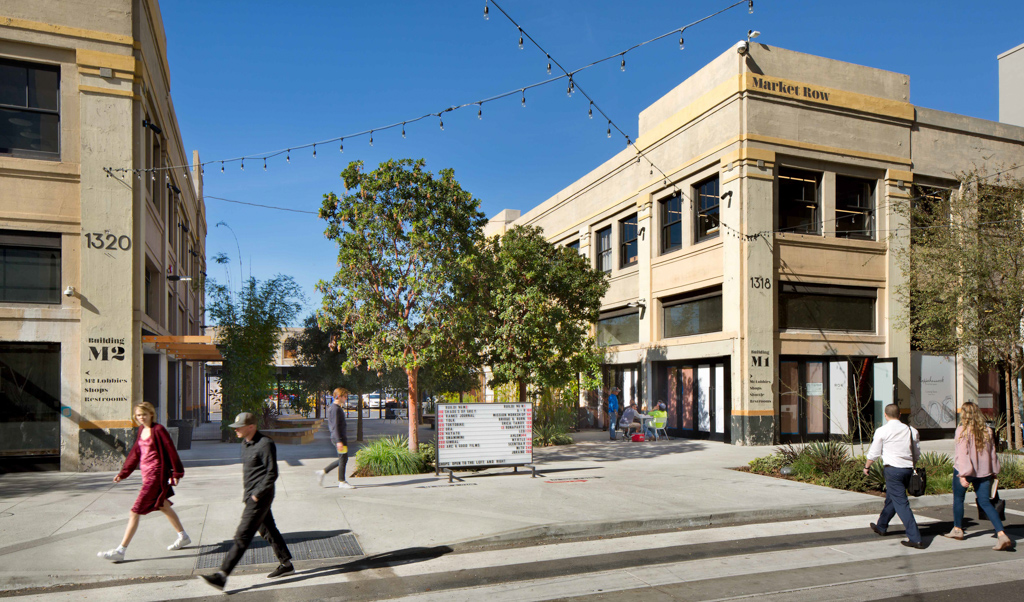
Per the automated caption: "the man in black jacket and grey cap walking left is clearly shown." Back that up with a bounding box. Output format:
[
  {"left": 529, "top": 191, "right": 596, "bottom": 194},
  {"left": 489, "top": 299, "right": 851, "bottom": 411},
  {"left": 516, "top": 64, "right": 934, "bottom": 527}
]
[{"left": 200, "top": 412, "right": 295, "bottom": 590}]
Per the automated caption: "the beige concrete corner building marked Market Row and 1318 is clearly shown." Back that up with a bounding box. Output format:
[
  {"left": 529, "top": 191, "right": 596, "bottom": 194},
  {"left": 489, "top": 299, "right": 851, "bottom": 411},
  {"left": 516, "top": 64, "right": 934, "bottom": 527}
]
[{"left": 488, "top": 43, "right": 1024, "bottom": 444}]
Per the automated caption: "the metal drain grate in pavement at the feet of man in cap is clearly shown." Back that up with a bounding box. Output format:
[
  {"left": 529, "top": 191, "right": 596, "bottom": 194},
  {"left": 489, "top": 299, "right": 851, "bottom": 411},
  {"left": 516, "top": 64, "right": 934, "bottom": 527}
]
[{"left": 196, "top": 531, "right": 362, "bottom": 569}]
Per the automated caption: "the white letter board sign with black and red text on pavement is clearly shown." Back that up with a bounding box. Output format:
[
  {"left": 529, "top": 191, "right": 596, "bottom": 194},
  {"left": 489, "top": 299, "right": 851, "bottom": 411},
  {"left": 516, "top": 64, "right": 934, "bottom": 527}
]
[{"left": 436, "top": 403, "right": 534, "bottom": 470}]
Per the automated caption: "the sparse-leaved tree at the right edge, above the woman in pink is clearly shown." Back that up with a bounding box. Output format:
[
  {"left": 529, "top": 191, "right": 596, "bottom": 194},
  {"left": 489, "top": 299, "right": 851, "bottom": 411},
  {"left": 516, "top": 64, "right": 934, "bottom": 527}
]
[{"left": 896, "top": 169, "right": 1024, "bottom": 448}]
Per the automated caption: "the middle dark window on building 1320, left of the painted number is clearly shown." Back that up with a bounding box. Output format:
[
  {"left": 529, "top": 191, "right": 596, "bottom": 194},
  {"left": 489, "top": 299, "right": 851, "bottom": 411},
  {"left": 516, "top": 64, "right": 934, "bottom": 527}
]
[{"left": 0, "top": 230, "right": 60, "bottom": 304}]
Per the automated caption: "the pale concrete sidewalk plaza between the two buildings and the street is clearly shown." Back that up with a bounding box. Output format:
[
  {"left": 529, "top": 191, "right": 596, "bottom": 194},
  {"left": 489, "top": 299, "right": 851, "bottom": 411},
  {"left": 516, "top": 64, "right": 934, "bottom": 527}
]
[{"left": 0, "top": 420, "right": 1003, "bottom": 591}]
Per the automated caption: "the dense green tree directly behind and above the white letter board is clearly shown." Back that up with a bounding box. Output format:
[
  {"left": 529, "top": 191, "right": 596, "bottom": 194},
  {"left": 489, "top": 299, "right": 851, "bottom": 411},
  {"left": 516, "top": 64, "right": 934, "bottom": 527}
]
[{"left": 480, "top": 226, "right": 608, "bottom": 401}]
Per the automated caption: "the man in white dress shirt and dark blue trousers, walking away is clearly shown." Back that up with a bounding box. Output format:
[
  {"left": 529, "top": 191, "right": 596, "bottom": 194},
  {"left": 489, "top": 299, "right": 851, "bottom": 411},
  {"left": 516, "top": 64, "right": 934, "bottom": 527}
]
[{"left": 864, "top": 403, "right": 925, "bottom": 549}]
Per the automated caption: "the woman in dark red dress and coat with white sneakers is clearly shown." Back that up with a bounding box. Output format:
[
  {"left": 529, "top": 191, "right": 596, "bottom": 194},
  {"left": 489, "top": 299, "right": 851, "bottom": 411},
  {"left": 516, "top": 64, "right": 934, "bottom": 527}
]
[{"left": 97, "top": 401, "right": 191, "bottom": 562}]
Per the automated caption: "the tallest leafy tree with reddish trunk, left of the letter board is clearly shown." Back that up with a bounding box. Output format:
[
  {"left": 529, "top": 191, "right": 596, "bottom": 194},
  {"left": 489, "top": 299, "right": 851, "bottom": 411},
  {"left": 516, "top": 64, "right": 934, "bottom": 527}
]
[{"left": 317, "top": 159, "right": 486, "bottom": 452}]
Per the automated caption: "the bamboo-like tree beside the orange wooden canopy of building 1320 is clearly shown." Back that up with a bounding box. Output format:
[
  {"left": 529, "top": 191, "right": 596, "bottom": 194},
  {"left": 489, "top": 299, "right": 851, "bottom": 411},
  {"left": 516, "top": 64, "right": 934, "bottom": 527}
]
[{"left": 207, "top": 274, "right": 304, "bottom": 430}]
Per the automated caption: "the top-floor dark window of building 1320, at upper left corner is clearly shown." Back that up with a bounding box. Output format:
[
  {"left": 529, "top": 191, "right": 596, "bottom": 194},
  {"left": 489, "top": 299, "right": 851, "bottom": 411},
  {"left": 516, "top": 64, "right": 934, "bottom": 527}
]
[{"left": 0, "top": 59, "right": 60, "bottom": 158}]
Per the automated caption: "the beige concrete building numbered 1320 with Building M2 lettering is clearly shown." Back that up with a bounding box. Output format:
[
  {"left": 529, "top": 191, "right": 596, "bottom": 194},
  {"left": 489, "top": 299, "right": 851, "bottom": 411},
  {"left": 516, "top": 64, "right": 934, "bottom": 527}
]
[{"left": 0, "top": 0, "right": 207, "bottom": 471}]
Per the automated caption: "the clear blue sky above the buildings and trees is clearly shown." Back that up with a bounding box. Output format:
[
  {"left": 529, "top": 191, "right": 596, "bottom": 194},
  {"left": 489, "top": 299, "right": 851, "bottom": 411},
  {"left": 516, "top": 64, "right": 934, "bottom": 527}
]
[{"left": 161, "top": 0, "right": 1024, "bottom": 313}]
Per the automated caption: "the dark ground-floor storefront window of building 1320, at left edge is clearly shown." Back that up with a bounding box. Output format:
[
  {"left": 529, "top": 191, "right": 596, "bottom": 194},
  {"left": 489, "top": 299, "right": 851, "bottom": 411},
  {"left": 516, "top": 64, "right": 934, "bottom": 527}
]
[{"left": 0, "top": 343, "right": 60, "bottom": 459}]
